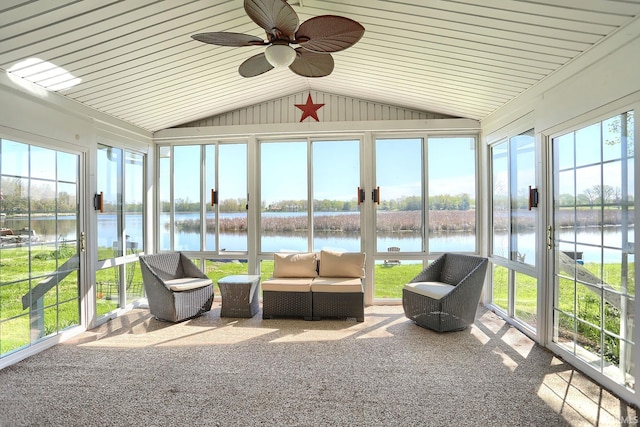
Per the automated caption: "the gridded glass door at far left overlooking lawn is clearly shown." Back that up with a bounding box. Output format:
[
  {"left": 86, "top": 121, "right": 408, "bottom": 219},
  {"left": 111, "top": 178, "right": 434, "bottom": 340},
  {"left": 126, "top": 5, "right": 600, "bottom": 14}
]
[{"left": 0, "top": 139, "right": 84, "bottom": 358}]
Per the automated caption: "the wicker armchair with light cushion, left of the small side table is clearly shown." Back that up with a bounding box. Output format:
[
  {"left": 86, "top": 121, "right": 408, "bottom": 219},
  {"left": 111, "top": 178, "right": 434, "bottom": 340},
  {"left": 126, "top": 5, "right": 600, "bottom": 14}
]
[{"left": 140, "top": 252, "right": 213, "bottom": 322}]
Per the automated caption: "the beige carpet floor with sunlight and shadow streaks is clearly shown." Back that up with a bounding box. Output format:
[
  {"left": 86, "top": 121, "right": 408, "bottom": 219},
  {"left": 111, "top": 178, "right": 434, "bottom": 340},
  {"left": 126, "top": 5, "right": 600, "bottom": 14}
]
[{"left": 0, "top": 301, "right": 636, "bottom": 427}]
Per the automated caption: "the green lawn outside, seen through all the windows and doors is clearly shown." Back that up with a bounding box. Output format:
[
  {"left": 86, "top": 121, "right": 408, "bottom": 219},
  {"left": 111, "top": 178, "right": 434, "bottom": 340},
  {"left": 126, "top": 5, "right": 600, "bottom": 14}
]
[{"left": 0, "top": 246, "right": 635, "bottom": 362}]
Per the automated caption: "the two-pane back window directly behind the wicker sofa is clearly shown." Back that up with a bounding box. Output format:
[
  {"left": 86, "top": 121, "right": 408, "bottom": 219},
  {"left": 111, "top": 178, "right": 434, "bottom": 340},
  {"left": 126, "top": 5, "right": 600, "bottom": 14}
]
[{"left": 260, "top": 140, "right": 361, "bottom": 252}]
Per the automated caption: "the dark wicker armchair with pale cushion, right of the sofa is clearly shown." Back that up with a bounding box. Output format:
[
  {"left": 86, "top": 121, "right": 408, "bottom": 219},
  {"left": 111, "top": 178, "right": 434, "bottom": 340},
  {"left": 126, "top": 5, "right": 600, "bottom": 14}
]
[{"left": 402, "top": 253, "right": 488, "bottom": 332}]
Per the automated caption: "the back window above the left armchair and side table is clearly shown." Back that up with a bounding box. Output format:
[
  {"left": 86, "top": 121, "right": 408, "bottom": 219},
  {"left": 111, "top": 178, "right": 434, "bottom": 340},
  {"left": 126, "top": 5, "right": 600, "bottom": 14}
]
[{"left": 158, "top": 143, "right": 248, "bottom": 254}]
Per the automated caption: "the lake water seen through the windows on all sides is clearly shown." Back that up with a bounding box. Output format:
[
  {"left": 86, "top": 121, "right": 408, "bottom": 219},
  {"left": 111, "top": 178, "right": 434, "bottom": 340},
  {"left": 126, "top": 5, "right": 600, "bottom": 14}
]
[{"left": 0, "top": 212, "right": 634, "bottom": 262}]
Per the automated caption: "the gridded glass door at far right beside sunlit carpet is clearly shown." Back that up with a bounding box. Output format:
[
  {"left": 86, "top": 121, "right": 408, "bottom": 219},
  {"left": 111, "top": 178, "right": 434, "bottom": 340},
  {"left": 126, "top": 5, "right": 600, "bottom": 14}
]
[{"left": 548, "top": 111, "right": 637, "bottom": 389}]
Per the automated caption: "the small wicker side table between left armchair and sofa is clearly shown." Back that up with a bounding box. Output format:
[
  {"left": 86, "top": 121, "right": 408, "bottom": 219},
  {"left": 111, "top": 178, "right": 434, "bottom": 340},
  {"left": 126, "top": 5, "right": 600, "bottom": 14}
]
[{"left": 218, "top": 274, "right": 260, "bottom": 317}]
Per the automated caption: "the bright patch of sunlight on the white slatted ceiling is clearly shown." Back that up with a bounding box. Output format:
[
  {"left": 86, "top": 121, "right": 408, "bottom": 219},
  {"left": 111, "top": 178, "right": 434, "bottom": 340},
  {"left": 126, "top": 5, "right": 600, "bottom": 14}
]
[{"left": 7, "top": 58, "right": 82, "bottom": 91}]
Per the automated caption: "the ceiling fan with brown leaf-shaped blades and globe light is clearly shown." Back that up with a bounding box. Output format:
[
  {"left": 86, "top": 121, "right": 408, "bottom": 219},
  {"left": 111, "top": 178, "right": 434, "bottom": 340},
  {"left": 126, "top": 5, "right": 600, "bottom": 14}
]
[{"left": 191, "top": 0, "right": 364, "bottom": 77}]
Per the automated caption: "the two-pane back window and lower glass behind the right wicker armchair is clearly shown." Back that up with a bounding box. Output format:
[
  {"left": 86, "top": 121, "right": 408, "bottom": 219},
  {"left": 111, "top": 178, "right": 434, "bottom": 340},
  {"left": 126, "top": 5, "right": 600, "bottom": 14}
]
[{"left": 374, "top": 136, "right": 477, "bottom": 299}]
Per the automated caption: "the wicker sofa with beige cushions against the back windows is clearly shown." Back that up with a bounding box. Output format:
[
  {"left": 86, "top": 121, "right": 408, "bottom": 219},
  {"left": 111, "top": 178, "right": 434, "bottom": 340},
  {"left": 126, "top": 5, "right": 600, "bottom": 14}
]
[{"left": 262, "top": 250, "right": 365, "bottom": 322}]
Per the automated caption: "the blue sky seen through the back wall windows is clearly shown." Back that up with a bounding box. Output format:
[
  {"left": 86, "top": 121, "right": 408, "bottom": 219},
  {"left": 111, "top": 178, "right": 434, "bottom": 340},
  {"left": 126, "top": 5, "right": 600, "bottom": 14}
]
[{"left": 152, "top": 137, "right": 475, "bottom": 205}]
